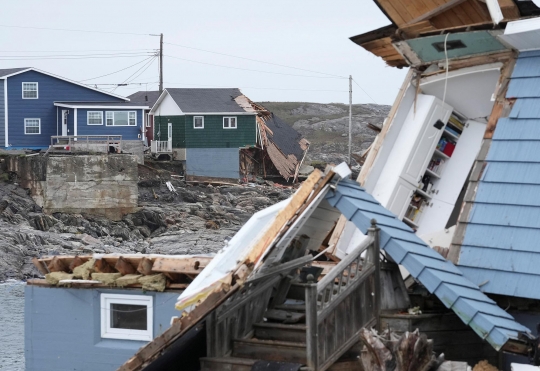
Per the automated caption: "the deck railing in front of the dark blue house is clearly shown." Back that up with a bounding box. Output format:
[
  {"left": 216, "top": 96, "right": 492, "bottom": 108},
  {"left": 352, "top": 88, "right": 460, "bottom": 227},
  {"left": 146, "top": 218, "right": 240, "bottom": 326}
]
[{"left": 49, "top": 135, "right": 122, "bottom": 153}]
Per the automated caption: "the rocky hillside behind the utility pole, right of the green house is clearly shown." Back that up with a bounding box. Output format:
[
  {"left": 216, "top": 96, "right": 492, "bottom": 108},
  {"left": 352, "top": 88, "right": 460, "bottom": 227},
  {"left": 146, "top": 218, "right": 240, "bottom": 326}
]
[{"left": 259, "top": 102, "right": 390, "bottom": 164}]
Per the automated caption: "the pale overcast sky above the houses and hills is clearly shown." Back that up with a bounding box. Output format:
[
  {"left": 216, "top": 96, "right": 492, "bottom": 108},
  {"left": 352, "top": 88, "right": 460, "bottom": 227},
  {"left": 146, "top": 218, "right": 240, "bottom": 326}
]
[{"left": 0, "top": 0, "right": 405, "bottom": 104}]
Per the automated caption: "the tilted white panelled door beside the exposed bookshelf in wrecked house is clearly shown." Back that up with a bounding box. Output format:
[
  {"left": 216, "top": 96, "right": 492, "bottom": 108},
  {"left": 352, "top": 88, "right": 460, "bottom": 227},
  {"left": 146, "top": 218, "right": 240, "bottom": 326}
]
[{"left": 401, "top": 99, "right": 452, "bottom": 185}]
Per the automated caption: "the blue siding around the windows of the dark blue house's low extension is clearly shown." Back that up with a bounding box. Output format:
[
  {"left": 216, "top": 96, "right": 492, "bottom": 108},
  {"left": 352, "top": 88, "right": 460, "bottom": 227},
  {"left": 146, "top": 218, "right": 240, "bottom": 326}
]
[{"left": 77, "top": 108, "right": 143, "bottom": 140}]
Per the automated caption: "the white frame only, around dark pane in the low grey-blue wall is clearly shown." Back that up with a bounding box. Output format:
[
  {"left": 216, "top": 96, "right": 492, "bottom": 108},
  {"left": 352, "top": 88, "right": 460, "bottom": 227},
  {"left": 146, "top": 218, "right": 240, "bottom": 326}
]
[{"left": 100, "top": 294, "right": 154, "bottom": 341}]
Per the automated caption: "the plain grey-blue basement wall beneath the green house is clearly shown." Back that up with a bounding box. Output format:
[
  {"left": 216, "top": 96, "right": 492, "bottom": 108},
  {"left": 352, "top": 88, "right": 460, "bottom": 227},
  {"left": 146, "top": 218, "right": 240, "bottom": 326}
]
[{"left": 186, "top": 148, "right": 240, "bottom": 179}]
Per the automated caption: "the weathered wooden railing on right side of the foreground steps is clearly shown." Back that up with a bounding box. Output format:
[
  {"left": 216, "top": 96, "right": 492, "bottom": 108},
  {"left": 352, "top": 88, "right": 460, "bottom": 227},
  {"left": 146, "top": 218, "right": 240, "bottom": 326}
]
[{"left": 306, "top": 222, "right": 380, "bottom": 371}]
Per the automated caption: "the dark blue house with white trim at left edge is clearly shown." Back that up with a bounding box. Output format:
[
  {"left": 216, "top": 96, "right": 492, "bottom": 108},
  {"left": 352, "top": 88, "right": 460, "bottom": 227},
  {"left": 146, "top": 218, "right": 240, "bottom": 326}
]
[{"left": 0, "top": 67, "right": 148, "bottom": 149}]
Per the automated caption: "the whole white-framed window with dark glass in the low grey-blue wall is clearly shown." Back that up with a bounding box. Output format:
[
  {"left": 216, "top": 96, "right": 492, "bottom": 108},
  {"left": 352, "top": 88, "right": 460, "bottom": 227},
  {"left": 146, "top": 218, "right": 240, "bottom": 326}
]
[{"left": 100, "top": 294, "right": 154, "bottom": 341}]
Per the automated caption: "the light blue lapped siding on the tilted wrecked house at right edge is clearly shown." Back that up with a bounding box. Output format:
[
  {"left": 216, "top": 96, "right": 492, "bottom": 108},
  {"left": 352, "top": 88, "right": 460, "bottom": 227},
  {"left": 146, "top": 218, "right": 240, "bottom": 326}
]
[{"left": 458, "top": 51, "right": 540, "bottom": 299}]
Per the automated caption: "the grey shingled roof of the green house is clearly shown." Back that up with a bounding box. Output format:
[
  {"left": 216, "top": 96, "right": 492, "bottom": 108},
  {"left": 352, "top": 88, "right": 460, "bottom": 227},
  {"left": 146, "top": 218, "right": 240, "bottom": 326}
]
[{"left": 165, "top": 88, "right": 246, "bottom": 113}]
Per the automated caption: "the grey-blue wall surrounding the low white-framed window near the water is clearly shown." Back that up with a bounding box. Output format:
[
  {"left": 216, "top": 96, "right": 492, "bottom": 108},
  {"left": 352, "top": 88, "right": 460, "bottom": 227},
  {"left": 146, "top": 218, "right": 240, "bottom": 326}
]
[{"left": 25, "top": 285, "right": 180, "bottom": 371}]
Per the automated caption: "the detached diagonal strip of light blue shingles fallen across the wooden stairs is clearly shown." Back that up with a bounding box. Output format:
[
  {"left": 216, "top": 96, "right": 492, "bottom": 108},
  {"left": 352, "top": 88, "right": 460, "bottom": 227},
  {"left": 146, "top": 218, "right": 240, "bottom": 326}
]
[{"left": 327, "top": 180, "right": 529, "bottom": 350}]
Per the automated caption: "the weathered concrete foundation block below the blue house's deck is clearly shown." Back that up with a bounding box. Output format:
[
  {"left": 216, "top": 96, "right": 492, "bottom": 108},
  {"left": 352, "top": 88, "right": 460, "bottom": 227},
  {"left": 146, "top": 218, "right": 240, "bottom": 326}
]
[{"left": 6, "top": 154, "right": 138, "bottom": 220}]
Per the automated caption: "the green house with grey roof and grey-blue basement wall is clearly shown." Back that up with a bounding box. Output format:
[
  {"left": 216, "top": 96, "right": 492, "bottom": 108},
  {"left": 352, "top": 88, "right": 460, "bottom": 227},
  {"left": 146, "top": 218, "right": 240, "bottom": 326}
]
[{"left": 149, "top": 88, "right": 259, "bottom": 179}]
